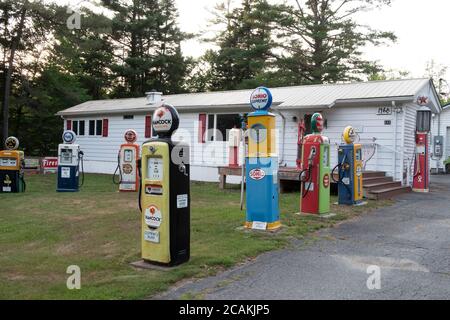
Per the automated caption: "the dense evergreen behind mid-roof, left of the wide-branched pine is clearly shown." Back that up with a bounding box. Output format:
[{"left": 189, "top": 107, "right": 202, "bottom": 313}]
[{"left": 197, "top": 0, "right": 276, "bottom": 90}]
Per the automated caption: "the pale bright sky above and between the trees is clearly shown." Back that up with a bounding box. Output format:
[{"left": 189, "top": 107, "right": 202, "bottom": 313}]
[{"left": 65, "top": 0, "right": 450, "bottom": 83}]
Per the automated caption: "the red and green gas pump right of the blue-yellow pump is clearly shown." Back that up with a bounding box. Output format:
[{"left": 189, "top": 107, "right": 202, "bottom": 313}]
[{"left": 300, "top": 113, "right": 331, "bottom": 214}]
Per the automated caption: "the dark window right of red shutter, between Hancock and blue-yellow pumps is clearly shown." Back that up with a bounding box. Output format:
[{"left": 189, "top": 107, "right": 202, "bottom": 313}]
[{"left": 208, "top": 113, "right": 243, "bottom": 141}]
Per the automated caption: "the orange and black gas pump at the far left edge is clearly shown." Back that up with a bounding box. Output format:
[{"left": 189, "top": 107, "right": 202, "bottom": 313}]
[{"left": 0, "top": 137, "right": 26, "bottom": 193}]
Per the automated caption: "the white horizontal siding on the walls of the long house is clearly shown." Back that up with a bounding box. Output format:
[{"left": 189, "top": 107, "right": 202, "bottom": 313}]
[{"left": 65, "top": 106, "right": 414, "bottom": 183}]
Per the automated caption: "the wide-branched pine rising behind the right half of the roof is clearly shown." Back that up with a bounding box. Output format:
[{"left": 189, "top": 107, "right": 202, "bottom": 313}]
[{"left": 277, "top": 0, "right": 396, "bottom": 85}]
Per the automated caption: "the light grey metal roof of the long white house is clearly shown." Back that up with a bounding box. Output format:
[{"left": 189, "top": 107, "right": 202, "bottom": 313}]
[{"left": 58, "top": 79, "right": 440, "bottom": 116}]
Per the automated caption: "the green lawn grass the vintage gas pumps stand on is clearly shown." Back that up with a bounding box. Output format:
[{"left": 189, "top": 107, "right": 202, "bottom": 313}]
[{"left": 0, "top": 174, "right": 390, "bottom": 299}]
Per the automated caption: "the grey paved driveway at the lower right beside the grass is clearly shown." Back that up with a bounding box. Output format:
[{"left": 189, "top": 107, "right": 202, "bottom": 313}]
[{"left": 159, "top": 176, "right": 450, "bottom": 300}]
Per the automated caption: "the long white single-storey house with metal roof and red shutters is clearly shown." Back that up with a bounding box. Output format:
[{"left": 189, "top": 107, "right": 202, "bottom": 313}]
[{"left": 58, "top": 79, "right": 440, "bottom": 184}]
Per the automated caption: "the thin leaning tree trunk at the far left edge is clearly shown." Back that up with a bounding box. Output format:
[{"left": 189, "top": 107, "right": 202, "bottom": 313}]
[{"left": 3, "top": 4, "right": 27, "bottom": 141}]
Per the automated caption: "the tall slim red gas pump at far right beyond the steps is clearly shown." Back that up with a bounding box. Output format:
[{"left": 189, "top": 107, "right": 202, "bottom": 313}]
[{"left": 413, "top": 104, "right": 431, "bottom": 192}]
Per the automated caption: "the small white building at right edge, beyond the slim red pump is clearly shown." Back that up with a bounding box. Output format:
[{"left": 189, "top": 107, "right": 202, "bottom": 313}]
[{"left": 431, "top": 104, "right": 450, "bottom": 172}]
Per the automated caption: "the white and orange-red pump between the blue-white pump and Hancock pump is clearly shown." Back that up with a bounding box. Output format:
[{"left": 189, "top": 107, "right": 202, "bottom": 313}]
[{"left": 113, "top": 129, "right": 140, "bottom": 192}]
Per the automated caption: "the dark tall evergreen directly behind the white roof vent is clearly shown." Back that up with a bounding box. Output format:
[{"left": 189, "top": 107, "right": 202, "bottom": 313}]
[{"left": 103, "top": 0, "right": 188, "bottom": 97}]
